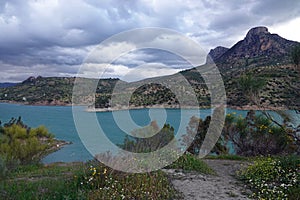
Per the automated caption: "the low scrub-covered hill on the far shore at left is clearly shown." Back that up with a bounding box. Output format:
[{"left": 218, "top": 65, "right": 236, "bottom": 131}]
[{"left": 0, "top": 76, "right": 119, "bottom": 105}]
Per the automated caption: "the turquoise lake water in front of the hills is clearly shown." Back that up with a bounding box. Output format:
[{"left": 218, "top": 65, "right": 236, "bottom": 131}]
[{"left": 0, "top": 103, "right": 298, "bottom": 163}]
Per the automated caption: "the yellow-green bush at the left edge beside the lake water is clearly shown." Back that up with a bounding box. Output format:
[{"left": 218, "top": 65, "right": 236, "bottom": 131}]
[{"left": 0, "top": 117, "right": 54, "bottom": 164}]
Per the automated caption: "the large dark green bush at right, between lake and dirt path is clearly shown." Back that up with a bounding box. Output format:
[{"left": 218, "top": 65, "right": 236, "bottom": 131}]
[{"left": 223, "top": 111, "right": 296, "bottom": 156}]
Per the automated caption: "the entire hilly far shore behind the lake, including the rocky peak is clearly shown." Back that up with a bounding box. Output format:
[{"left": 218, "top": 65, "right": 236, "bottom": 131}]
[{"left": 0, "top": 27, "right": 300, "bottom": 109}]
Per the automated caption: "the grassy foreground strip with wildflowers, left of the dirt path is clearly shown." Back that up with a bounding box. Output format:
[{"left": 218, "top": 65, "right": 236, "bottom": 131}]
[{"left": 0, "top": 161, "right": 177, "bottom": 200}]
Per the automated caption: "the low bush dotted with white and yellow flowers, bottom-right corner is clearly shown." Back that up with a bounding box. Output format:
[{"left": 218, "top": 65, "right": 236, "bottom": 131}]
[{"left": 239, "top": 156, "right": 300, "bottom": 200}]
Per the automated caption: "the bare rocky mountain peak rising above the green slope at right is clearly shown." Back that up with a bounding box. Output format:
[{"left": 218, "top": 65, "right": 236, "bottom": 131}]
[{"left": 208, "top": 27, "right": 299, "bottom": 71}]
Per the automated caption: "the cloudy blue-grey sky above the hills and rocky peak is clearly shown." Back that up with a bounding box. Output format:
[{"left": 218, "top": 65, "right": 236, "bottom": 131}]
[{"left": 0, "top": 0, "right": 300, "bottom": 82}]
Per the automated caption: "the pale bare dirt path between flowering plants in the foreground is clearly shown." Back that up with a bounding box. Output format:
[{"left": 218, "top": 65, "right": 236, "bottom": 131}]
[{"left": 166, "top": 160, "right": 249, "bottom": 200}]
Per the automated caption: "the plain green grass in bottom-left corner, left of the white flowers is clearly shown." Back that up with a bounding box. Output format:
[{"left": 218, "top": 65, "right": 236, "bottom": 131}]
[{"left": 0, "top": 163, "right": 83, "bottom": 200}]
